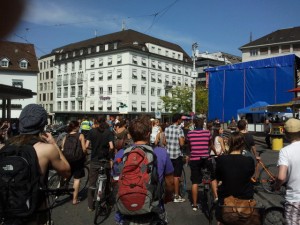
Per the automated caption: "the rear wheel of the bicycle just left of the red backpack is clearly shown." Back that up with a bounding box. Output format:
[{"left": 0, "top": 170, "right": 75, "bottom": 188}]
[{"left": 94, "top": 181, "right": 109, "bottom": 224}]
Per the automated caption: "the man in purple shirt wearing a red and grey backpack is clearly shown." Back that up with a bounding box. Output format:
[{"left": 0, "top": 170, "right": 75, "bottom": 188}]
[{"left": 113, "top": 116, "right": 174, "bottom": 224}]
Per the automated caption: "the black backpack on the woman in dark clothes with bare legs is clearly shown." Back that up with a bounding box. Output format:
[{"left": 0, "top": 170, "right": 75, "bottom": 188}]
[{"left": 63, "top": 133, "right": 84, "bottom": 162}]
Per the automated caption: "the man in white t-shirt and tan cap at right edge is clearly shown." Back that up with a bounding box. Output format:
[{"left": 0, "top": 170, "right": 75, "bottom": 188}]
[{"left": 275, "top": 118, "right": 300, "bottom": 225}]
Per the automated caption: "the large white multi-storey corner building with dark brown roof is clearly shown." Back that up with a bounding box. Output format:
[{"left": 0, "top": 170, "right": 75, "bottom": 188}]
[{"left": 40, "top": 30, "right": 194, "bottom": 122}]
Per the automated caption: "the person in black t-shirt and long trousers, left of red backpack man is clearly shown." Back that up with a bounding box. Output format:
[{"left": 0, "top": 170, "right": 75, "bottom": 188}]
[{"left": 86, "top": 117, "right": 114, "bottom": 211}]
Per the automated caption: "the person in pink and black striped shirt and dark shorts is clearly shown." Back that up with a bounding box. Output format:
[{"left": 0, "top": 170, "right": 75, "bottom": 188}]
[{"left": 187, "top": 118, "right": 217, "bottom": 211}]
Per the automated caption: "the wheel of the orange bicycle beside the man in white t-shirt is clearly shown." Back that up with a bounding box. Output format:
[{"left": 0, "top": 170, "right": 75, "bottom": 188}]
[{"left": 259, "top": 164, "right": 285, "bottom": 194}]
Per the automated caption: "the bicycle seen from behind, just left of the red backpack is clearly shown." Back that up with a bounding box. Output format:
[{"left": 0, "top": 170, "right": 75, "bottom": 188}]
[{"left": 94, "top": 159, "right": 112, "bottom": 224}]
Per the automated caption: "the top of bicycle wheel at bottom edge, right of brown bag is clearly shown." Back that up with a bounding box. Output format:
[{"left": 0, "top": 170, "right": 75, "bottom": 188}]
[{"left": 263, "top": 206, "right": 285, "bottom": 225}]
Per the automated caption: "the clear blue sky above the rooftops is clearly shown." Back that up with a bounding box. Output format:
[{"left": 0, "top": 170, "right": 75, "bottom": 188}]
[{"left": 6, "top": 0, "right": 300, "bottom": 56}]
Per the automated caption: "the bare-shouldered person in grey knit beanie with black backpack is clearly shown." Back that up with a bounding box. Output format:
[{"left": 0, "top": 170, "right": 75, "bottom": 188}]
[{"left": 0, "top": 104, "right": 70, "bottom": 225}]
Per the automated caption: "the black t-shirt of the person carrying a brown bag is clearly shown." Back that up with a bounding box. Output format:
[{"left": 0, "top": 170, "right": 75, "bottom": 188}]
[{"left": 216, "top": 155, "right": 255, "bottom": 199}]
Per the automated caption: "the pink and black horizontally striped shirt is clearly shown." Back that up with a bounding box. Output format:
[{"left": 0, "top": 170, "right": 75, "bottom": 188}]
[{"left": 187, "top": 129, "right": 211, "bottom": 160}]
